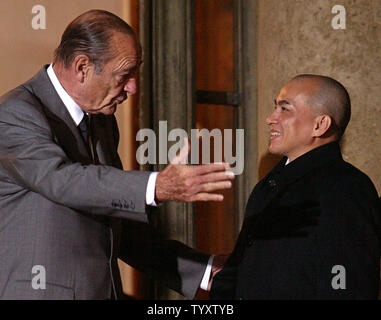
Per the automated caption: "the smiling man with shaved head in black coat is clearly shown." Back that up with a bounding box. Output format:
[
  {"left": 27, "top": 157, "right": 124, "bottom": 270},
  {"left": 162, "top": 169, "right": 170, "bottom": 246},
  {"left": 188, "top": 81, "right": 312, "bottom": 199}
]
[{"left": 210, "top": 75, "right": 381, "bottom": 300}]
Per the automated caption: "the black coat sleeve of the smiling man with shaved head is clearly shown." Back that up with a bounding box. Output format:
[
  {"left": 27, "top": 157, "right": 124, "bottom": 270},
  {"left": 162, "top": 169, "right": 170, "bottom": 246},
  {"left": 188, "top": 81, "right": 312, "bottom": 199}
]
[{"left": 315, "top": 174, "right": 381, "bottom": 299}]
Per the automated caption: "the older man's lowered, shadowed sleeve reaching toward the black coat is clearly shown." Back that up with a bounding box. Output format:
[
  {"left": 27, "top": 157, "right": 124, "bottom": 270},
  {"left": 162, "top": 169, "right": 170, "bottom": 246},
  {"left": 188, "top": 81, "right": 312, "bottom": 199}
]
[{"left": 118, "top": 220, "right": 209, "bottom": 299}]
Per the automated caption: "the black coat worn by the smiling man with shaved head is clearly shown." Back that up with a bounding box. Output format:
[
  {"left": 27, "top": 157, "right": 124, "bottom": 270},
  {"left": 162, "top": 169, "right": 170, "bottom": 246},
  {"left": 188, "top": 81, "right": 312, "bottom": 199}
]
[{"left": 211, "top": 142, "right": 381, "bottom": 299}]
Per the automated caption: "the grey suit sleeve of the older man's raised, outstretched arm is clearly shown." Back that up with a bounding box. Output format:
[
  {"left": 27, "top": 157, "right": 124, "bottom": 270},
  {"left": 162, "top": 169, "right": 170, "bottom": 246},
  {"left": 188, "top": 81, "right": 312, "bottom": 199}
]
[{"left": 0, "top": 99, "right": 149, "bottom": 216}]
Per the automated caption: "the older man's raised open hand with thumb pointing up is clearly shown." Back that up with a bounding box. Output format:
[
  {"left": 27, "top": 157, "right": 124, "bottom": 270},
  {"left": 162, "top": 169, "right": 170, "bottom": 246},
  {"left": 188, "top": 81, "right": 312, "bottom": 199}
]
[{"left": 155, "top": 139, "right": 234, "bottom": 202}]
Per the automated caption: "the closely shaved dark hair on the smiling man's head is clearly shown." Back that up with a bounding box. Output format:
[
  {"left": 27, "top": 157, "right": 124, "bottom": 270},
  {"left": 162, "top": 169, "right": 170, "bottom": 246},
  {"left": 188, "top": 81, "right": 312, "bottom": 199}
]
[{"left": 291, "top": 74, "right": 351, "bottom": 140}]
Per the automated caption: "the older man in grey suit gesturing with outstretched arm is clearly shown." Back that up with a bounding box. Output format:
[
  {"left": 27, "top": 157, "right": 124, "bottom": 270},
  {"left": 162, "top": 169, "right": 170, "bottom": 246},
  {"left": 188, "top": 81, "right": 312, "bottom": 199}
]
[{"left": 0, "top": 10, "right": 232, "bottom": 299}]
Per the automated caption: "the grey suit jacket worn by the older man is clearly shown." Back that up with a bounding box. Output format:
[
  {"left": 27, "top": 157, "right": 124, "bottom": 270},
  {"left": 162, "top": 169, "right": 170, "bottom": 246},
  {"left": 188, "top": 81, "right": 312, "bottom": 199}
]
[{"left": 0, "top": 66, "right": 208, "bottom": 299}]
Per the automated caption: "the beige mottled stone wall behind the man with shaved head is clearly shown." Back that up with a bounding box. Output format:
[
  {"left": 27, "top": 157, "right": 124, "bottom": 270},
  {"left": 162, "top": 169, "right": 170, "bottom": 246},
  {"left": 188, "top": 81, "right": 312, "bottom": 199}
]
[{"left": 258, "top": 0, "right": 381, "bottom": 194}]
